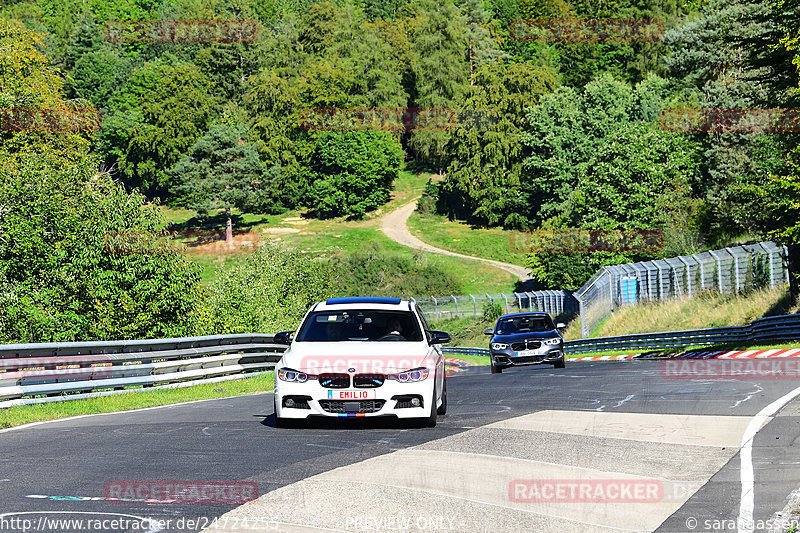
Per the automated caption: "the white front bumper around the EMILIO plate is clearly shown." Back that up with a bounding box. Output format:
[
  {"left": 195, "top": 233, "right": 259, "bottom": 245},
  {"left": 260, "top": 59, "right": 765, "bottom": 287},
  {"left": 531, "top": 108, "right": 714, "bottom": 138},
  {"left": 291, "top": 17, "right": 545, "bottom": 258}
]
[{"left": 275, "top": 375, "right": 435, "bottom": 419}]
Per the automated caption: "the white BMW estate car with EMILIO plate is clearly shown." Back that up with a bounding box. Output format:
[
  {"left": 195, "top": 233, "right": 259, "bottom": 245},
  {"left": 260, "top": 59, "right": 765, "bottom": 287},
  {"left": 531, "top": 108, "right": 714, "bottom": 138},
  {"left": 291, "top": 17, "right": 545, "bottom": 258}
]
[{"left": 274, "top": 297, "right": 450, "bottom": 427}]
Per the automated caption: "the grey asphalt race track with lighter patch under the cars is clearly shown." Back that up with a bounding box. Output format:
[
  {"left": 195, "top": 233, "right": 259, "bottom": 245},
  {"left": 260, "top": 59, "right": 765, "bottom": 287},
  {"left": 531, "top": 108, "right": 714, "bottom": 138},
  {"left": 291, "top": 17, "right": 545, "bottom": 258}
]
[{"left": 0, "top": 361, "right": 800, "bottom": 533}]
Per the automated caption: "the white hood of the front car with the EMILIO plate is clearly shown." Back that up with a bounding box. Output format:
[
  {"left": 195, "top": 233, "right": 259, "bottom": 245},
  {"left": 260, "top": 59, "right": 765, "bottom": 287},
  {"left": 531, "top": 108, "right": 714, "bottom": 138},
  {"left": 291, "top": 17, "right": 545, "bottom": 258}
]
[{"left": 282, "top": 341, "right": 435, "bottom": 374}]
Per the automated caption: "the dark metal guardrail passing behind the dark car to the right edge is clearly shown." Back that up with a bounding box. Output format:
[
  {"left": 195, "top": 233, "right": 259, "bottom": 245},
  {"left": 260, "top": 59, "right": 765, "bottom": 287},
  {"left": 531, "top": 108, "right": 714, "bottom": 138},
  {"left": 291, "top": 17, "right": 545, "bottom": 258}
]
[{"left": 443, "top": 314, "right": 800, "bottom": 356}]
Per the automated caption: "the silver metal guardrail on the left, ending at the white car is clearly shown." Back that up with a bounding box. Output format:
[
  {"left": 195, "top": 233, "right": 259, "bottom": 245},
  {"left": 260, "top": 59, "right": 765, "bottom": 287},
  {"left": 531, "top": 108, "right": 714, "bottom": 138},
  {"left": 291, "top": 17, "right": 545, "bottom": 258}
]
[{"left": 0, "top": 334, "right": 286, "bottom": 408}]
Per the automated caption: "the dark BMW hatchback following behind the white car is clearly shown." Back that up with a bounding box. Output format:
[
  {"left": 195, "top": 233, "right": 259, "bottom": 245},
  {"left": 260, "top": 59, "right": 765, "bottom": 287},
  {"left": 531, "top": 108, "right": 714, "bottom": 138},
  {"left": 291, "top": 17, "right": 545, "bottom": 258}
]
[{"left": 484, "top": 313, "right": 565, "bottom": 374}]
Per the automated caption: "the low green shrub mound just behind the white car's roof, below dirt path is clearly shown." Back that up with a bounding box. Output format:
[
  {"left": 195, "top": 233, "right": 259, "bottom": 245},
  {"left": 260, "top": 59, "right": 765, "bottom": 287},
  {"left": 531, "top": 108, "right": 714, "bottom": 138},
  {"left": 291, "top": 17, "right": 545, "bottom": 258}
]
[{"left": 334, "top": 243, "right": 463, "bottom": 296}]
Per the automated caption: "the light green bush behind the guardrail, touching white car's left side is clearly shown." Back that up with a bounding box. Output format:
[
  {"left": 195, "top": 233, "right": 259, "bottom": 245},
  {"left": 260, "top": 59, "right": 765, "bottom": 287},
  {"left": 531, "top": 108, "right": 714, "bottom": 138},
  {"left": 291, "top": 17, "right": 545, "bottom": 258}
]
[{"left": 196, "top": 245, "right": 335, "bottom": 334}]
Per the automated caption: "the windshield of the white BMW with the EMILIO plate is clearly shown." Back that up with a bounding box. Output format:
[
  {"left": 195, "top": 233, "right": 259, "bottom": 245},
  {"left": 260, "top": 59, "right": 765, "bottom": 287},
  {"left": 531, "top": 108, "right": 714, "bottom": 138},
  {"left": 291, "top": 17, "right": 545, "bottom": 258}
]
[{"left": 296, "top": 309, "right": 422, "bottom": 342}]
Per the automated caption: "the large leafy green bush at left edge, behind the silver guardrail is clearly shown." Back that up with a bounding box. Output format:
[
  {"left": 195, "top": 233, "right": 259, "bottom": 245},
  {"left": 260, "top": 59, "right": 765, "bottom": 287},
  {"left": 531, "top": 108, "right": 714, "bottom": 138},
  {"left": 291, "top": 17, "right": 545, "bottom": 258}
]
[{"left": 0, "top": 154, "right": 201, "bottom": 342}]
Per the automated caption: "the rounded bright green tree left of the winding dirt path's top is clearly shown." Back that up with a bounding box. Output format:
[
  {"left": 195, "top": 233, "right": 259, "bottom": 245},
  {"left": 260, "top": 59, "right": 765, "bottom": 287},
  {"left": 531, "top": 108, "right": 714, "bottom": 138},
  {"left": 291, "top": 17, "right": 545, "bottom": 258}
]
[{"left": 308, "top": 132, "right": 403, "bottom": 218}]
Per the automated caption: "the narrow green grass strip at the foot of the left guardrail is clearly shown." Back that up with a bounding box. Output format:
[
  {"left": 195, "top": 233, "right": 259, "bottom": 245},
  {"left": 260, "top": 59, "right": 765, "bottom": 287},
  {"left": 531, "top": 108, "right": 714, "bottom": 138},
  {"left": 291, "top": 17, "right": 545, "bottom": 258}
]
[{"left": 0, "top": 372, "right": 274, "bottom": 429}]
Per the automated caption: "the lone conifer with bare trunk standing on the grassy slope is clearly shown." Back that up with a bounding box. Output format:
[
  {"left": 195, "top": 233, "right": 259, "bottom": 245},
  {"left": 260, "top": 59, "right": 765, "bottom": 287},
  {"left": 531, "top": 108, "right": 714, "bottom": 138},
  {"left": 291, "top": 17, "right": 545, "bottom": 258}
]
[{"left": 170, "top": 124, "right": 277, "bottom": 245}]
